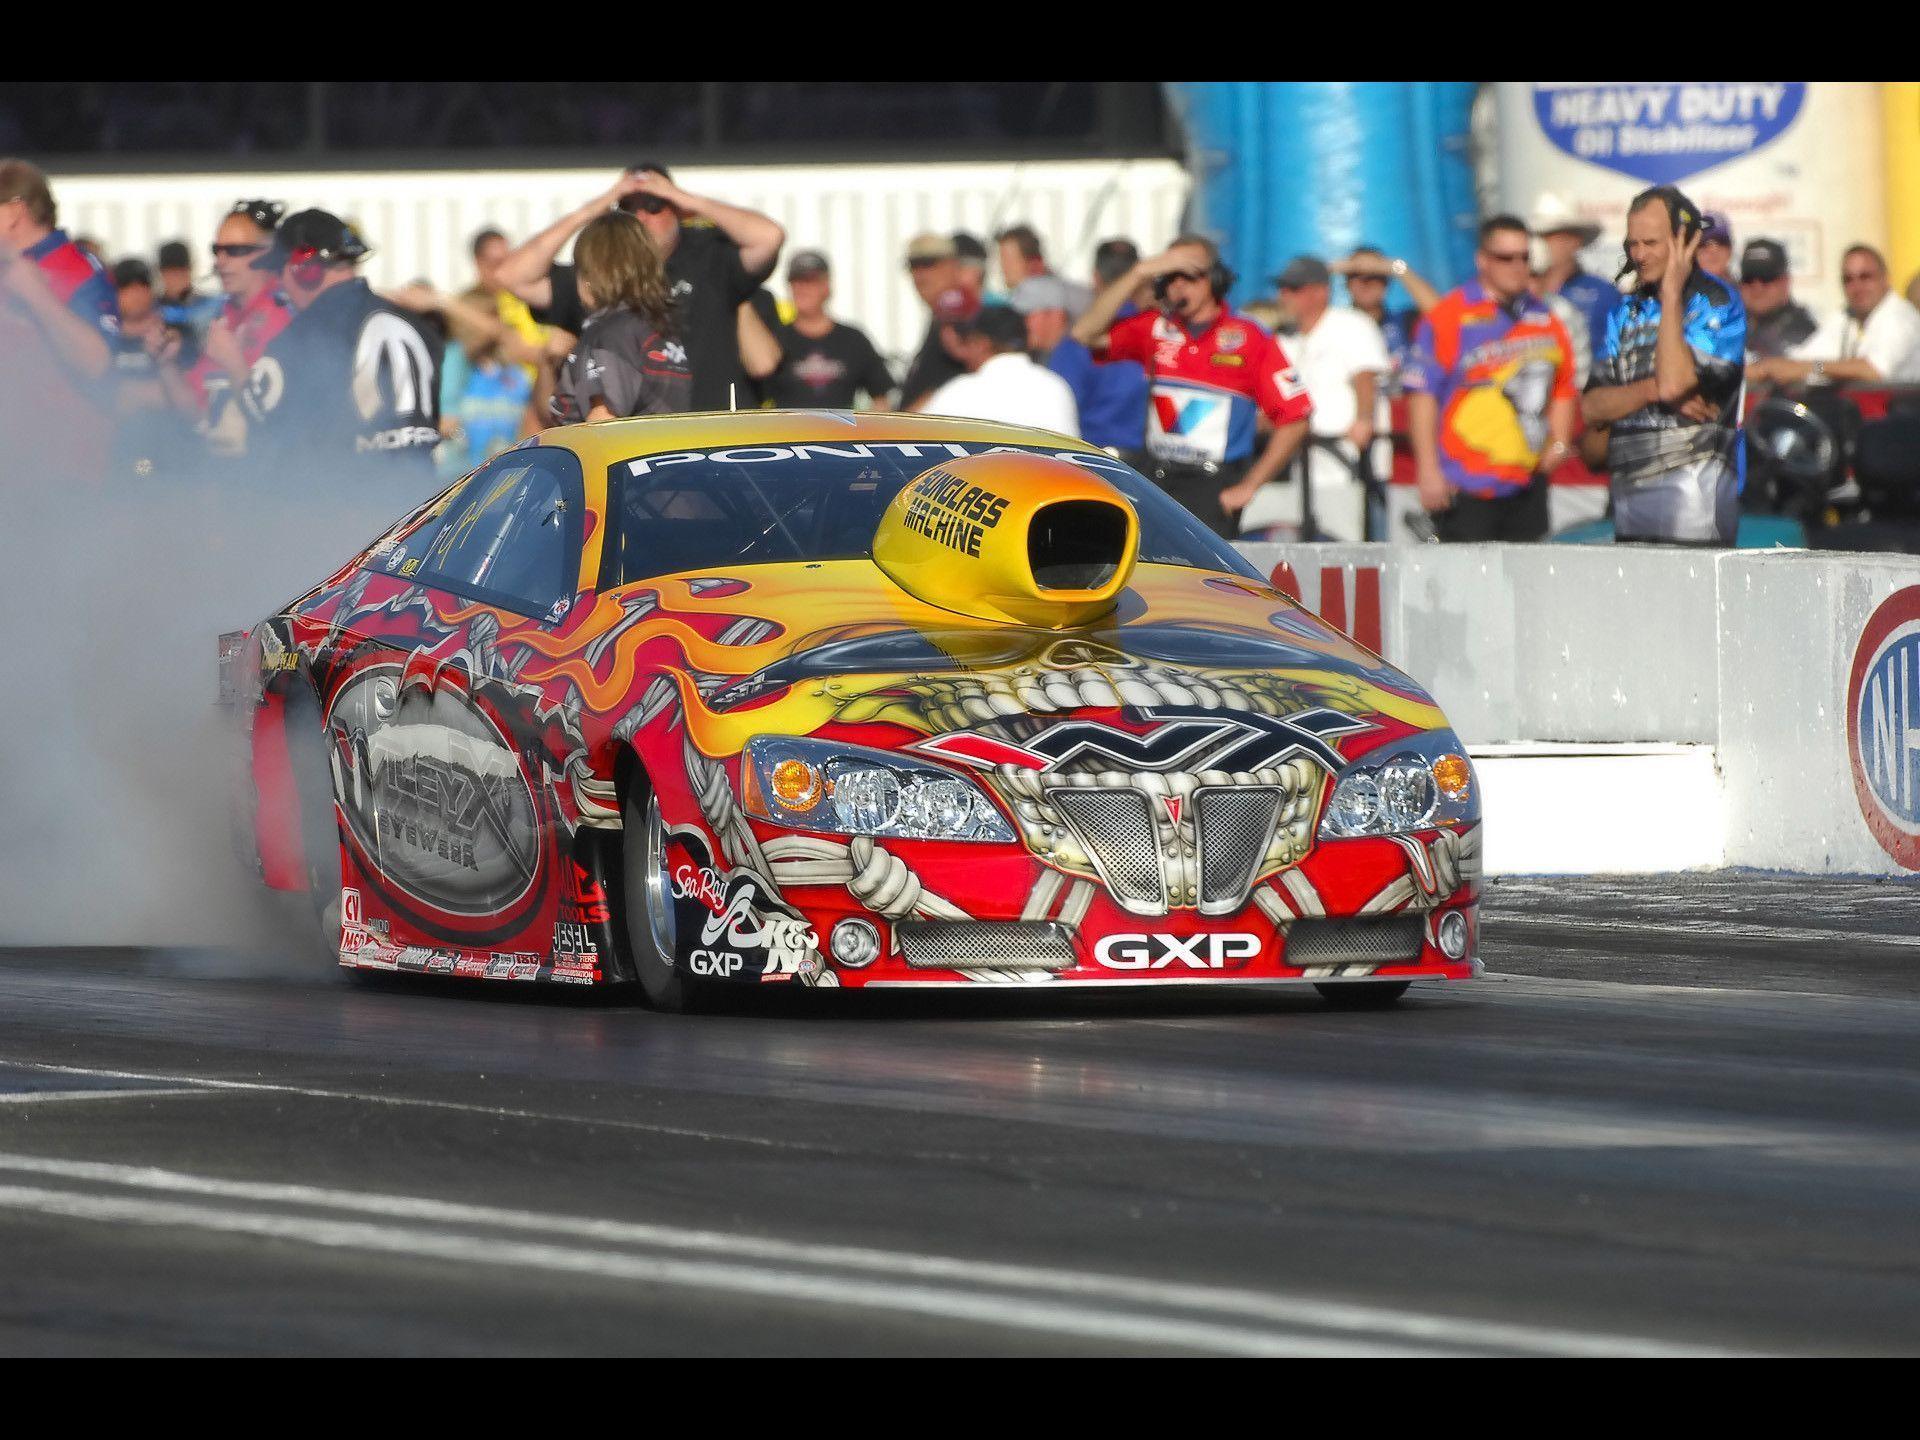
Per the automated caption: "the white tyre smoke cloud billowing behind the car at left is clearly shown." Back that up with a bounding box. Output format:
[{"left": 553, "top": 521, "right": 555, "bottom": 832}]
[{"left": 0, "top": 368, "right": 430, "bottom": 954}]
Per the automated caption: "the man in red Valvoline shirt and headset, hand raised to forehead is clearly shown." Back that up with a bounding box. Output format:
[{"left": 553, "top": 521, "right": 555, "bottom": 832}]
[{"left": 1073, "top": 234, "right": 1313, "bottom": 538}]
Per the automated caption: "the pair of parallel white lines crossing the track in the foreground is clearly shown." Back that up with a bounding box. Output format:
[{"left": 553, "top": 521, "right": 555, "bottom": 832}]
[{"left": 0, "top": 1152, "right": 1711, "bottom": 1356}]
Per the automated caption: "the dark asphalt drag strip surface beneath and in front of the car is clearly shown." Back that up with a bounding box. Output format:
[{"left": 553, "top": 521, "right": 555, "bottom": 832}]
[{"left": 0, "top": 876, "right": 1920, "bottom": 1356}]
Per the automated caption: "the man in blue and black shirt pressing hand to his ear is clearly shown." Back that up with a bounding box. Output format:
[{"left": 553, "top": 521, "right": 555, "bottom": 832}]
[{"left": 1580, "top": 186, "right": 1747, "bottom": 545}]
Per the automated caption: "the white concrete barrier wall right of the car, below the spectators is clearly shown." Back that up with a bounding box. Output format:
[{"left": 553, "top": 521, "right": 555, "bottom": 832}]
[{"left": 1240, "top": 543, "right": 1920, "bottom": 876}]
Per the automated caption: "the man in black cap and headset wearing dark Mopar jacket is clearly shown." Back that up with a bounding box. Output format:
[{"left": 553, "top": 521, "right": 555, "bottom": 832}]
[{"left": 240, "top": 209, "right": 440, "bottom": 493}]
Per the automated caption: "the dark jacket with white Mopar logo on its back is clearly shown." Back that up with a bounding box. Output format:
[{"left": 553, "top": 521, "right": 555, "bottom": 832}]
[{"left": 242, "top": 280, "right": 440, "bottom": 478}]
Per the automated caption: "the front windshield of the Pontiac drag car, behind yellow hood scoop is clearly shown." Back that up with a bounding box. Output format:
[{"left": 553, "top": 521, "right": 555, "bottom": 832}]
[{"left": 607, "top": 440, "right": 1261, "bottom": 584}]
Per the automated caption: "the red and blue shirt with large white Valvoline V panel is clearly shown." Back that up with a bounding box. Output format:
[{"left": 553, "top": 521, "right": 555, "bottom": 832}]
[{"left": 1102, "top": 311, "right": 1313, "bottom": 465}]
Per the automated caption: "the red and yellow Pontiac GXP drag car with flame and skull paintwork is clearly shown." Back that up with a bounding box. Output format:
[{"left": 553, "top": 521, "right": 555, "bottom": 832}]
[{"left": 223, "top": 411, "right": 1480, "bottom": 1010}]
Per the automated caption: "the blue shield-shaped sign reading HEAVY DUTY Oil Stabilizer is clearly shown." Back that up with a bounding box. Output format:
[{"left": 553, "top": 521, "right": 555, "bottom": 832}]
[{"left": 1534, "top": 81, "right": 1807, "bottom": 184}]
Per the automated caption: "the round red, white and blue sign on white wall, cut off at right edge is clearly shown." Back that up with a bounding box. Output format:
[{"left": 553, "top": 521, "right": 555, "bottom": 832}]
[{"left": 1847, "top": 586, "right": 1920, "bottom": 870}]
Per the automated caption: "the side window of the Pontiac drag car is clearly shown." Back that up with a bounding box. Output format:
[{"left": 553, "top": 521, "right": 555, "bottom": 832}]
[{"left": 409, "top": 447, "right": 586, "bottom": 616}]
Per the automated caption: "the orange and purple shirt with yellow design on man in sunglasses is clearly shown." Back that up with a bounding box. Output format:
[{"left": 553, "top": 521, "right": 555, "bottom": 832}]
[{"left": 1402, "top": 280, "right": 1576, "bottom": 497}]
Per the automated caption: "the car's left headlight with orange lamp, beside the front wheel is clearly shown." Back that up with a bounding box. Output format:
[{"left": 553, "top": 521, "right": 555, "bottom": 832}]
[{"left": 741, "top": 735, "right": 1014, "bottom": 845}]
